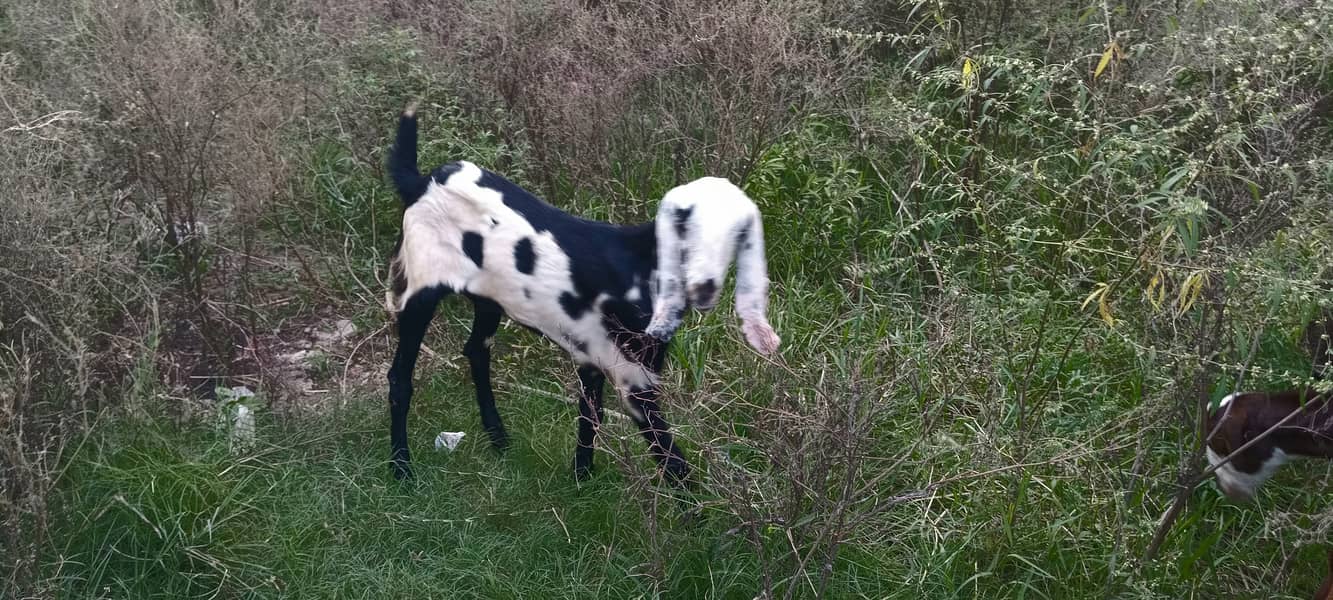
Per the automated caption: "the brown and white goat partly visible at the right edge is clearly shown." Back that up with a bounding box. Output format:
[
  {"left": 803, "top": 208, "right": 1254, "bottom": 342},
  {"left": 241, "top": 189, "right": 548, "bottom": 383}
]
[{"left": 1205, "top": 389, "right": 1333, "bottom": 501}]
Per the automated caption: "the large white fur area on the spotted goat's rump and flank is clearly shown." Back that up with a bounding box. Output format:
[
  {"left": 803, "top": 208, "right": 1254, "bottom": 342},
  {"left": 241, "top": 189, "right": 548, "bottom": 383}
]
[{"left": 395, "top": 161, "right": 657, "bottom": 408}]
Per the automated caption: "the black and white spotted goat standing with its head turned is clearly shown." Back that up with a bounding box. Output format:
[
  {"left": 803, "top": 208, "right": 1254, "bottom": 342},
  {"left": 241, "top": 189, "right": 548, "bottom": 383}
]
[{"left": 387, "top": 107, "right": 778, "bottom": 481}]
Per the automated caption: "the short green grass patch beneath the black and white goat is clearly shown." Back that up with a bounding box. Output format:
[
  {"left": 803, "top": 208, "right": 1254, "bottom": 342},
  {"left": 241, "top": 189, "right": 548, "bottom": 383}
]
[{"left": 56, "top": 365, "right": 881, "bottom": 597}]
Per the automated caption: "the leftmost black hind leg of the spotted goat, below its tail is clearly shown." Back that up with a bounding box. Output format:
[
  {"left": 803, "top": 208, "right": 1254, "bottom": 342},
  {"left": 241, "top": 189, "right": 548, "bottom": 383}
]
[{"left": 389, "top": 288, "right": 448, "bottom": 480}]
